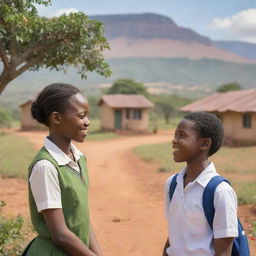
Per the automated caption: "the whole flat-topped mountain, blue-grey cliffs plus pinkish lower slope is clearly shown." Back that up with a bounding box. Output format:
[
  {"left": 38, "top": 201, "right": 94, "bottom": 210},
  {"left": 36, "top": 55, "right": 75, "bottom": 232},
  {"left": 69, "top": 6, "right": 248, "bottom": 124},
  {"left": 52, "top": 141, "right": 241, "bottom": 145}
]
[{"left": 90, "top": 13, "right": 256, "bottom": 63}]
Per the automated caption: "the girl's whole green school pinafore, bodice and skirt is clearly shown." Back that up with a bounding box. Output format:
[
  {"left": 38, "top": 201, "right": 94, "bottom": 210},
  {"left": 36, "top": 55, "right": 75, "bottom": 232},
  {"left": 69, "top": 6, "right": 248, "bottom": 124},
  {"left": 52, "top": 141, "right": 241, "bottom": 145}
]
[{"left": 23, "top": 147, "right": 89, "bottom": 256}]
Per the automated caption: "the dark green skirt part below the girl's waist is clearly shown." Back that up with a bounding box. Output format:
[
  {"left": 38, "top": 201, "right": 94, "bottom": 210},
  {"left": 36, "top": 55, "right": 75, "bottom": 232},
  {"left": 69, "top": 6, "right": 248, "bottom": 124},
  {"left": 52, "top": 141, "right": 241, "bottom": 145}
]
[{"left": 22, "top": 236, "right": 68, "bottom": 256}]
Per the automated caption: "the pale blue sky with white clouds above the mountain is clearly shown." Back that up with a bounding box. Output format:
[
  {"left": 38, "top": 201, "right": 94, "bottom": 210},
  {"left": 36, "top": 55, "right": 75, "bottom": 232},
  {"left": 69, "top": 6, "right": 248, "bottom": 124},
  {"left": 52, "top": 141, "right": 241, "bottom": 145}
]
[{"left": 38, "top": 0, "right": 256, "bottom": 43}]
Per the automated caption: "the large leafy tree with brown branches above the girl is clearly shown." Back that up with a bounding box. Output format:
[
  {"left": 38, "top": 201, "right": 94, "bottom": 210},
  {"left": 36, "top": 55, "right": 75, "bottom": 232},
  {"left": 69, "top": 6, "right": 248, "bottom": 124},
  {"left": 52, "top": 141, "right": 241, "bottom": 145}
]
[{"left": 0, "top": 0, "right": 111, "bottom": 94}]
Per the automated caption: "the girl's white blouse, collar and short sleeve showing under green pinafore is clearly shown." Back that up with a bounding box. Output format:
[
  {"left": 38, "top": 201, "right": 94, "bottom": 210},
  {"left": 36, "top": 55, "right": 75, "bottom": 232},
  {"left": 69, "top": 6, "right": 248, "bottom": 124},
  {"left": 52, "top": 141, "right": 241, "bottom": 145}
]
[{"left": 29, "top": 138, "right": 83, "bottom": 212}]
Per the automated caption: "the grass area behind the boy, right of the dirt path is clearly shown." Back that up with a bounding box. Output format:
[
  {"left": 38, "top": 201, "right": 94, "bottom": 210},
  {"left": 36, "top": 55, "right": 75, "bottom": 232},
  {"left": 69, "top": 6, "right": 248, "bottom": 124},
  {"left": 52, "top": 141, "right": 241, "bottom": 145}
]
[{"left": 134, "top": 143, "right": 256, "bottom": 204}]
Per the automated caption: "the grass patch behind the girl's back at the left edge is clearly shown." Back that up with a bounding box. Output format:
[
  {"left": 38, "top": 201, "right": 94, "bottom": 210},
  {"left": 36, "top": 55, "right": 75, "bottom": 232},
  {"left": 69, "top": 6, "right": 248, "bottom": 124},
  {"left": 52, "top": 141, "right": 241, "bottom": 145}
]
[{"left": 0, "top": 132, "right": 36, "bottom": 178}]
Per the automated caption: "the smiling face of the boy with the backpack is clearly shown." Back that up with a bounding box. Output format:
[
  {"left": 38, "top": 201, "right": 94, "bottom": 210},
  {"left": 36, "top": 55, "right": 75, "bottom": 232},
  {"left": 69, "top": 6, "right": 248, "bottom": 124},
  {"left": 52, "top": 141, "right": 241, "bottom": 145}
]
[{"left": 172, "top": 119, "right": 204, "bottom": 163}]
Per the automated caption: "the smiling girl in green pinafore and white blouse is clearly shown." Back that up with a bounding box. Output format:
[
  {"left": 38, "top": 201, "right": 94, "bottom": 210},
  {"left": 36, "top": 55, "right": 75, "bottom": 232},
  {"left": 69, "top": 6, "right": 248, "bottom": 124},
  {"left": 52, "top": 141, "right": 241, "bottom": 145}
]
[{"left": 23, "top": 83, "right": 103, "bottom": 256}]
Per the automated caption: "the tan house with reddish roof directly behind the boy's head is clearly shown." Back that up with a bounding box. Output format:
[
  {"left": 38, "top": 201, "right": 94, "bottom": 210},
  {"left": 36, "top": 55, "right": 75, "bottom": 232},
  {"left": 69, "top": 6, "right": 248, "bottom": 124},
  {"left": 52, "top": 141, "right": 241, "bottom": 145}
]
[{"left": 181, "top": 90, "right": 256, "bottom": 145}]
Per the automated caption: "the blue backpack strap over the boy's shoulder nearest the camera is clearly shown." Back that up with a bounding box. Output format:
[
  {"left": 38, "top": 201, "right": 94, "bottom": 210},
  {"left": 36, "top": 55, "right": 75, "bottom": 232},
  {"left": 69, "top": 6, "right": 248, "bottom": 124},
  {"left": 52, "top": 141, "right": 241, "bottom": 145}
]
[{"left": 203, "top": 175, "right": 230, "bottom": 229}]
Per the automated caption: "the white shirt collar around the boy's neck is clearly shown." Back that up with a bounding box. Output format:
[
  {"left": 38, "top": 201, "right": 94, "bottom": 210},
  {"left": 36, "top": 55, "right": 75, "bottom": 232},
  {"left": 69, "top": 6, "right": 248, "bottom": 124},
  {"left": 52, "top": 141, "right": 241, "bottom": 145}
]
[{"left": 177, "top": 162, "right": 217, "bottom": 187}]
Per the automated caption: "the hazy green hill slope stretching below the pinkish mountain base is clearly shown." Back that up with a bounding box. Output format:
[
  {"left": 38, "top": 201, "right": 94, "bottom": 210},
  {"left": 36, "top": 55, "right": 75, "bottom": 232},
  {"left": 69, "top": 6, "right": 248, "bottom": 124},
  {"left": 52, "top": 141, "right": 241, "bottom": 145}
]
[{"left": 1, "top": 58, "right": 256, "bottom": 105}]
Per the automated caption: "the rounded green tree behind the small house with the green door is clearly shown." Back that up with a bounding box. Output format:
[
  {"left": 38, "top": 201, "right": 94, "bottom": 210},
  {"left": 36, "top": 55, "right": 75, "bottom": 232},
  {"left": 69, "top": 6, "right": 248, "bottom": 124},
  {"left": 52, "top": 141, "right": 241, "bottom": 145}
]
[{"left": 107, "top": 79, "right": 148, "bottom": 96}]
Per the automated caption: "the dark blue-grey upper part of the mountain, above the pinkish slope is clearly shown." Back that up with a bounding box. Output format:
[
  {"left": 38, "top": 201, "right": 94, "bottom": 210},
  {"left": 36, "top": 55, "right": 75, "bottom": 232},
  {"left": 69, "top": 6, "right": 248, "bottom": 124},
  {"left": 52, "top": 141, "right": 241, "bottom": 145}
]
[{"left": 91, "top": 13, "right": 211, "bottom": 45}]
